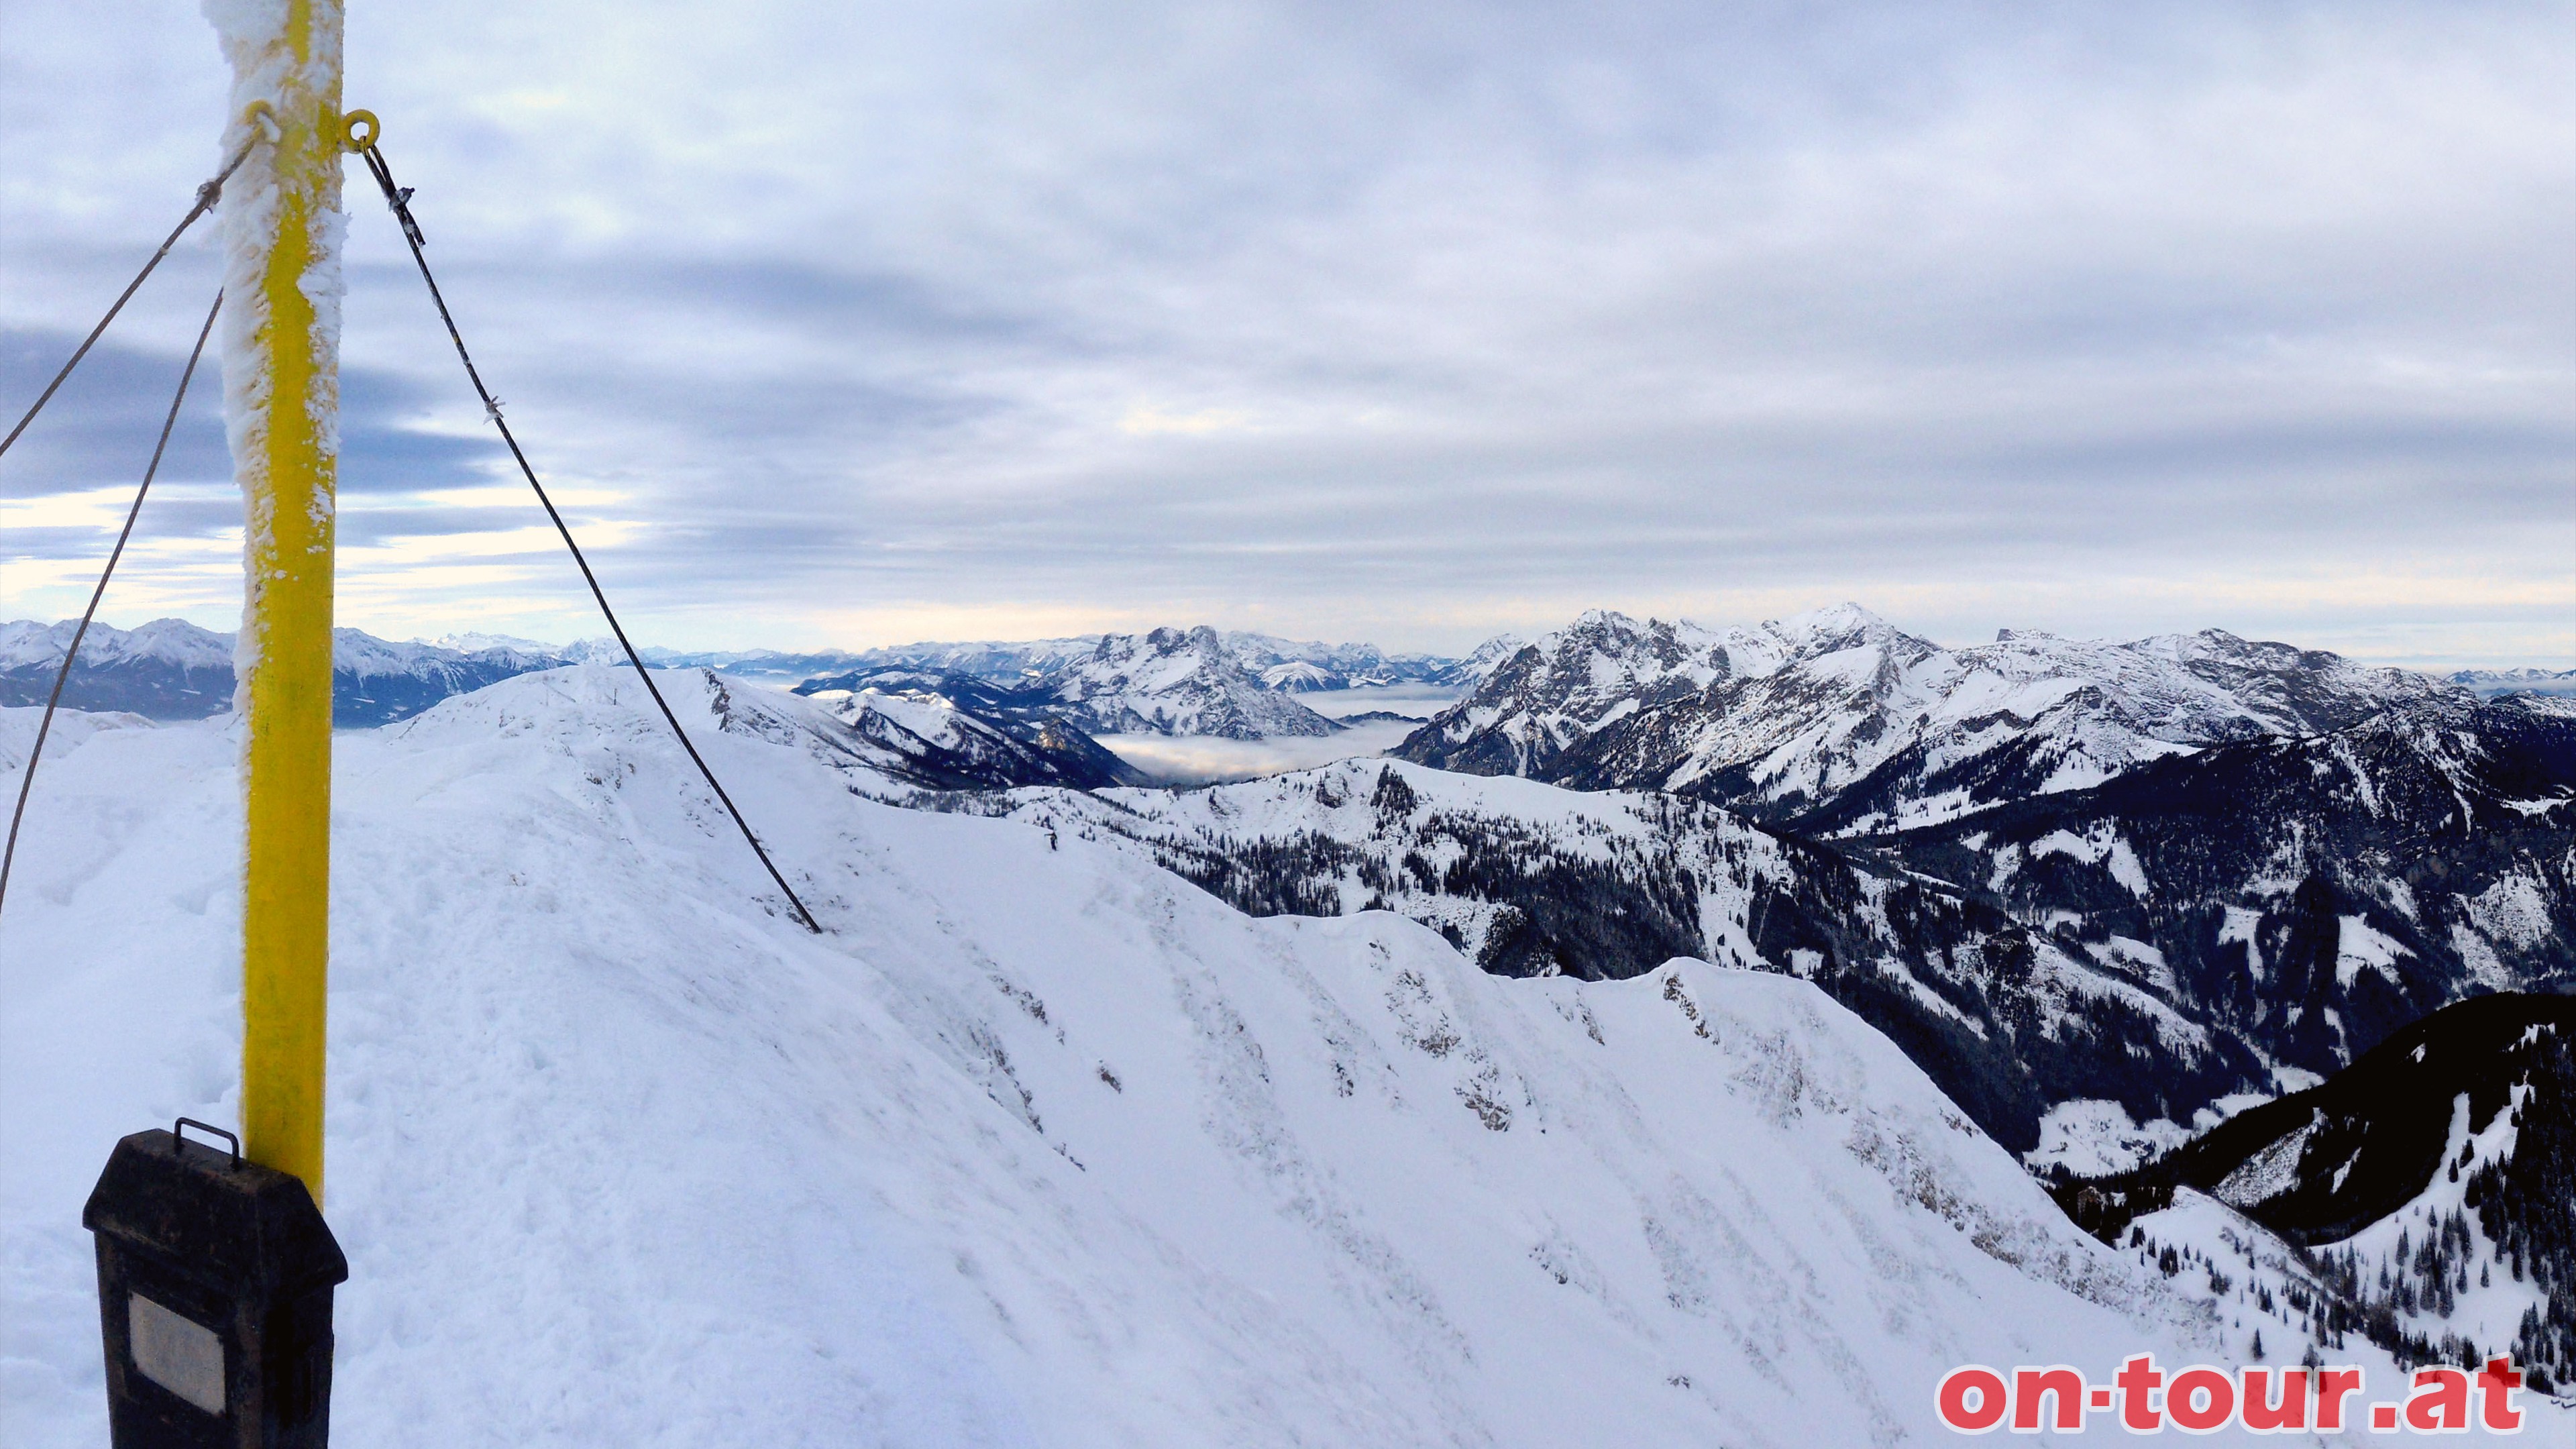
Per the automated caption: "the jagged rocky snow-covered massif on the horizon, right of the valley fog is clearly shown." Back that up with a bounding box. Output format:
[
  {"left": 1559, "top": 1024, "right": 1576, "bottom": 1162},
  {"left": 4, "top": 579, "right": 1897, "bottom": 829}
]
[{"left": 1404, "top": 603, "right": 2457, "bottom": 833}]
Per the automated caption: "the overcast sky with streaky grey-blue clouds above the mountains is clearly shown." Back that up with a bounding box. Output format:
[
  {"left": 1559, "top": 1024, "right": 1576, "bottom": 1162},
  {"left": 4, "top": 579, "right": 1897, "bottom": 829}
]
[{"left": 0, "top": 0, "right": 2576, "bottom": 667}]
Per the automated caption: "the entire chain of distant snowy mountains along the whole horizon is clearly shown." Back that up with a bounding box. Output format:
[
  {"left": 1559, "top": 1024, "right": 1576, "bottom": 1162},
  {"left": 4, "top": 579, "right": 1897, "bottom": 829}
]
[{"left": 20, "top": 606, "right": 2576, "bottom": 757}]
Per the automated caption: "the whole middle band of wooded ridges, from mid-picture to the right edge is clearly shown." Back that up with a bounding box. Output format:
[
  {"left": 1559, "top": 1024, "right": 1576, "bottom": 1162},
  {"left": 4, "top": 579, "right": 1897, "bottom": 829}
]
[{"left": 966, "top": 699, "right": 2576, "bottom": 1150}]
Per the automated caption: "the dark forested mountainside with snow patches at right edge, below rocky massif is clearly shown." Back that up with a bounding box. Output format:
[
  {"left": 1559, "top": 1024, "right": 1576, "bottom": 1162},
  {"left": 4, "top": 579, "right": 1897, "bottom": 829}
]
[{"left": 1849, "top": 699, "right": 2576, "bottom": 1073}]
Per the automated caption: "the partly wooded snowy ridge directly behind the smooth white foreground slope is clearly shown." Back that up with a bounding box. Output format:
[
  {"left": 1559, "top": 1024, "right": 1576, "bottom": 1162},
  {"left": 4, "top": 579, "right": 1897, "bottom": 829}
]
[{"left": 968, "top": 761, "right": 2272, "bottom": 1150}]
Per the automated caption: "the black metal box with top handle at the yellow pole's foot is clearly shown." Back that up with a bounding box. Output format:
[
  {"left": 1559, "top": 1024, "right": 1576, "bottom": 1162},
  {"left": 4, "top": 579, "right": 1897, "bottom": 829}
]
[{"left": 80, "top": 1122, "right": 347, "bottom": 1449}]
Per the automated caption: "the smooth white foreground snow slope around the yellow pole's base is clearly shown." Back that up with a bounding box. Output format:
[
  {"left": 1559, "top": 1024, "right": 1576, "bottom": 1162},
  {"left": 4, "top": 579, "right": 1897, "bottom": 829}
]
[{"left": 0, "top": 670, "right": 2218, "bottom": 1449}]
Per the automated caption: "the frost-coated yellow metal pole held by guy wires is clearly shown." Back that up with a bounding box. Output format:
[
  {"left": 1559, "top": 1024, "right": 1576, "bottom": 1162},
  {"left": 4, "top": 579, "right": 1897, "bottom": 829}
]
[{"left": 217, "top": 0, "right": 343, "bottom": 1204}]
